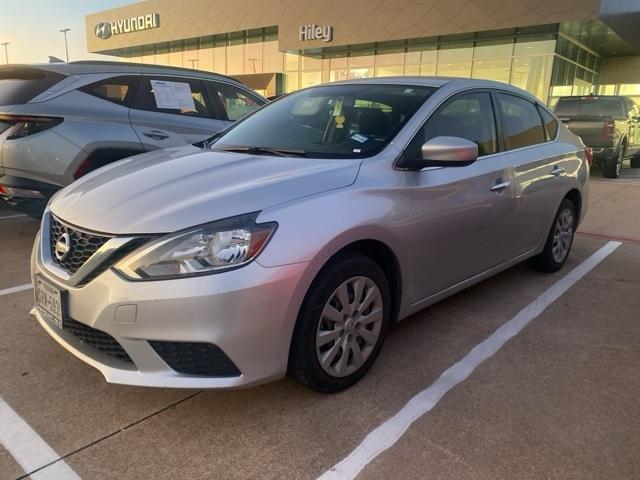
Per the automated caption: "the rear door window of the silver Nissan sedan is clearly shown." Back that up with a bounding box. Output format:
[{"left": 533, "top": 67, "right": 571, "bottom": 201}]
[{"left": 498, "top": 93, "right": 546, "bottom": 150}]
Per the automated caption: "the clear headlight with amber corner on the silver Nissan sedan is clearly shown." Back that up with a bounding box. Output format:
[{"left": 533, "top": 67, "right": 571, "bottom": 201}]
[{"left": 114, "top": 213, "right": 278, "bottom": 280}]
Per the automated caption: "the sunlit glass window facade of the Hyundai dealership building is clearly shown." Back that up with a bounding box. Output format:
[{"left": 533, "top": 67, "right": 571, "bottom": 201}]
[{"left": 114, "top": 25, "right": 604, "bottom": 105}]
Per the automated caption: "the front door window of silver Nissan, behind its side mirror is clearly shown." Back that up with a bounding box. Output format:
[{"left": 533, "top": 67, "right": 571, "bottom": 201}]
[{"left": 408, "top": 92, "right": 498, "bottom": 156}]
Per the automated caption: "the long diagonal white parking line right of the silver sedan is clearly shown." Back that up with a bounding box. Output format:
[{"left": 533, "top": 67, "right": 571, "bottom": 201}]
[{"left": 319, "top": 242, "right": 622, "bottom": 480}]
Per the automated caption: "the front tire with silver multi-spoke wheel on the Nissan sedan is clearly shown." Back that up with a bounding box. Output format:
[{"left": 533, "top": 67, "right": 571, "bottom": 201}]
[{"left": 288, "top": 252, "right": 391, "bottom": 393}]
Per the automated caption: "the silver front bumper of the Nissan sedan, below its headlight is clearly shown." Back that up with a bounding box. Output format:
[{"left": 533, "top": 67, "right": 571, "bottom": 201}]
[{"left": 31, "top": 236, "right": 307, "bottom": 388}]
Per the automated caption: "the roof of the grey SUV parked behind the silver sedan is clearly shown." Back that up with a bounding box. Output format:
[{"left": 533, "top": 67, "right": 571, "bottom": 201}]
[{"left": 2, "top": 60, "right": 241, "bottom": 84}]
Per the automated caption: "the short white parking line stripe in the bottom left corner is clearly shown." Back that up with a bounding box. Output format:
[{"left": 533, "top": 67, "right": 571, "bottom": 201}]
[{"left": 0, "top": 398, "right": 80, "bottom": 480}]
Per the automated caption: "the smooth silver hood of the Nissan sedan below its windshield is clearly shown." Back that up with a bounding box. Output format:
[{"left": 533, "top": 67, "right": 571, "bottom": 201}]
[{"left": 49, "top": 146, "right": 361, "bottom": 234}]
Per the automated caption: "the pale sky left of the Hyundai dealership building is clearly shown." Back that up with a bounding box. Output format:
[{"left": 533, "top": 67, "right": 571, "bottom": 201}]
[{"left": 0, "top": 0, "right": 136, "bottom": 64}]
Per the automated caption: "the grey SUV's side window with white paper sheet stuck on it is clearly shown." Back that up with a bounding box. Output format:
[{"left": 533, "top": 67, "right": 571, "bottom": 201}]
[{"left": 133, "top": 77, "right": 213, "bottom": 118}]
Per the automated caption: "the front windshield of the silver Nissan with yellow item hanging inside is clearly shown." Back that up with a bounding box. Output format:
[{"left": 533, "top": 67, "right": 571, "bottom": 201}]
[{"left": 210, "top": 84, "right": 436, "bottom": 158}]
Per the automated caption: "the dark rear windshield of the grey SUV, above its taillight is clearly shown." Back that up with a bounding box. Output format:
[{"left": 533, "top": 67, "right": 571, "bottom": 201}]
[{"left": 0, "top": 66, "right": 66, "bottom": 106}]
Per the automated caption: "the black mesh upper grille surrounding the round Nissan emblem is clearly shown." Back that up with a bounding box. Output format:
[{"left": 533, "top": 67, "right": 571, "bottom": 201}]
[{"left": 49, "top": 215, "right": 111, "bottom": 275}]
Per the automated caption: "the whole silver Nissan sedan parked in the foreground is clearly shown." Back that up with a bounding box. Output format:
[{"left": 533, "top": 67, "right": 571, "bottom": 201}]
[{"left": 31, "top": 77, "right": 589, "bottom": 392}]
